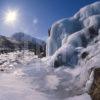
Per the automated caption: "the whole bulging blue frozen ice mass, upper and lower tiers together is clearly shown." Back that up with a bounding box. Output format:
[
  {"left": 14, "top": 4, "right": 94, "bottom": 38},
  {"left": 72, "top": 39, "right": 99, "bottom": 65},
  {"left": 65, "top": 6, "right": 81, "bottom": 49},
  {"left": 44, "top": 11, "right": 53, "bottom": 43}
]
[{"left": 47, "top": 2, "right": 100, "bottom": 67}]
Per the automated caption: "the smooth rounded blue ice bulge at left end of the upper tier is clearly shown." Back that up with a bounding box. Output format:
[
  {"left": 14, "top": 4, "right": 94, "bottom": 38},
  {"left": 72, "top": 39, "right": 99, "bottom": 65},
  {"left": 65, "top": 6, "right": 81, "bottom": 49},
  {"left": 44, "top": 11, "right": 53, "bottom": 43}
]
[{"left": 47, "top": 18, "right": 81, "bottom": 56}]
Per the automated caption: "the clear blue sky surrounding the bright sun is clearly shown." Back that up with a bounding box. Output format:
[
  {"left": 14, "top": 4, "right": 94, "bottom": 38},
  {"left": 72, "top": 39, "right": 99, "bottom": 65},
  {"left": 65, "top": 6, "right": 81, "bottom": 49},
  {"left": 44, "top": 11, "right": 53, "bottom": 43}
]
[{"left": 0, "top": 0, "right": 99, "bottom": 40}]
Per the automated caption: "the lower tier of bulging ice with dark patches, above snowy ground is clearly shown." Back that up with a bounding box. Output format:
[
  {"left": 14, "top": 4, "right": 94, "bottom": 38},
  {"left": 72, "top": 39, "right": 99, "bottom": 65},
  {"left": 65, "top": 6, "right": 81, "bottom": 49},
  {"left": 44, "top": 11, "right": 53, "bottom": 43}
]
[{"left": 50, "top": 24, "right": 98, "bottom": 67}]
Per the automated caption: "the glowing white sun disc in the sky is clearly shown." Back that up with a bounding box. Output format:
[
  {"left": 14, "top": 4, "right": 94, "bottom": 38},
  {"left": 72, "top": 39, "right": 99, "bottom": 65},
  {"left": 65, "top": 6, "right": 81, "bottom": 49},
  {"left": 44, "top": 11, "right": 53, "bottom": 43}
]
[{"left": 4, "top": 10, "right": 18, "bottom": 24}]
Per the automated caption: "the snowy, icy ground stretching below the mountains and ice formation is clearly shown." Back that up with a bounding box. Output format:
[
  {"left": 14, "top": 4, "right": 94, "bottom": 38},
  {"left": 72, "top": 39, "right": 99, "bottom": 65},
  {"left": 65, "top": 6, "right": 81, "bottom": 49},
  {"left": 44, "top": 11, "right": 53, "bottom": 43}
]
[{"left": 0, "top": 51, "right": 91, "bottom": 100}]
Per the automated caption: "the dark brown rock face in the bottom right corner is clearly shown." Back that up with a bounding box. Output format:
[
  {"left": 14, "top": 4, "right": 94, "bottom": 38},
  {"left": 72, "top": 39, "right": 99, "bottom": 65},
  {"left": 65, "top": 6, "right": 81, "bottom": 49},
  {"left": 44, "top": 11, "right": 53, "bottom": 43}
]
[{"left": 89, "top": 68, "right": 100, "bottom": 100}]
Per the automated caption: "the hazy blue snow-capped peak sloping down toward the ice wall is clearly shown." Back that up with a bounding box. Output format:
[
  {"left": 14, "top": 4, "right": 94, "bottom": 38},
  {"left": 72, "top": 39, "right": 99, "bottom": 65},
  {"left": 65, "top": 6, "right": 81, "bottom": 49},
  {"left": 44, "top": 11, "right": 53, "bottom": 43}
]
[{"left": 11, "top": 32, "right": 46, "bottom": 57}]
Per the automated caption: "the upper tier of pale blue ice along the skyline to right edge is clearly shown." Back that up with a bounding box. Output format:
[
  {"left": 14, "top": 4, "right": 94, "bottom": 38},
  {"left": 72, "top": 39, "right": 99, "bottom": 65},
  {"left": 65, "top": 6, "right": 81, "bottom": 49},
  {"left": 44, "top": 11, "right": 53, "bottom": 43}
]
[{"left": 47, "top": 2, "right": 100, "bottom": 56}]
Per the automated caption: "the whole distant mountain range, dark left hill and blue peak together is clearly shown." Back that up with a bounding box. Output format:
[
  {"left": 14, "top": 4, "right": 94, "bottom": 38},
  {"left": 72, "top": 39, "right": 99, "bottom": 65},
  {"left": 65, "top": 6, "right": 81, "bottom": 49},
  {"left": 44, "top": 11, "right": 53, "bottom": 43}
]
[{"left": 0, "top": 32, "right": 46, "bottom": 57}]
